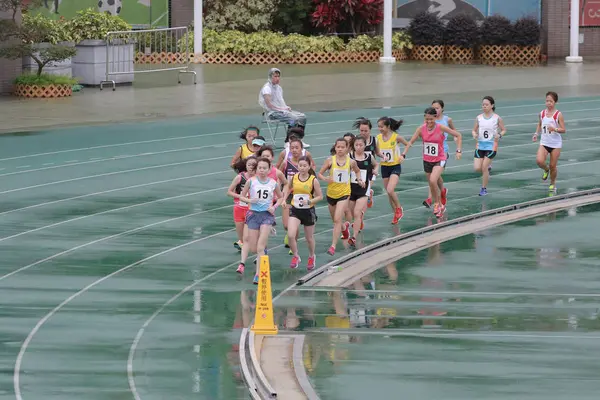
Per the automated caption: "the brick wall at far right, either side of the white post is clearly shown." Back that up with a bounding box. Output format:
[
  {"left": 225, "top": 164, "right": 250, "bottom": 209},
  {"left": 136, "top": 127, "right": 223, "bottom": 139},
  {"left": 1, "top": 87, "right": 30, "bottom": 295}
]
[{"left": 542, "top": 0, "right": 600, "bottom": 57}]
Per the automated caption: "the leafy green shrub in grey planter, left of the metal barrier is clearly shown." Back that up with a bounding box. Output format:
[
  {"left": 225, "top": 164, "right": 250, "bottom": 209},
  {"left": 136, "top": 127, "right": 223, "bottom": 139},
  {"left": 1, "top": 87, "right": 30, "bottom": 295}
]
[{"left": 20, "top": 13, "right": 75, "bottom": 77}]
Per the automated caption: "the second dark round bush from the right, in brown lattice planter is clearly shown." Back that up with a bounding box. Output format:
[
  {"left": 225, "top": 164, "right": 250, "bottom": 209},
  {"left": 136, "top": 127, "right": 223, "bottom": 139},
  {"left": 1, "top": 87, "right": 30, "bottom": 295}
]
[{"left": 479, "top": 15, "right": 513, "bottom": 65}]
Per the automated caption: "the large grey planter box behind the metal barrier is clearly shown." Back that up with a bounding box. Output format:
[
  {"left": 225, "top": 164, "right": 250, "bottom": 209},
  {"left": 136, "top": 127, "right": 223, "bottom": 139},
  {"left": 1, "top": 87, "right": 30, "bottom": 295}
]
[{"left": 72, "top": 40, "right": 135, "bottom": 86}]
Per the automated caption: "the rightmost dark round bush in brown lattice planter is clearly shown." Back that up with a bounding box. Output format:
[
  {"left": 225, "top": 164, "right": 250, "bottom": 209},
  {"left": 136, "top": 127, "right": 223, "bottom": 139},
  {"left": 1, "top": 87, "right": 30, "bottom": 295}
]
[{"left": 512, "top": 17, "right": 541, "bottom": 66}]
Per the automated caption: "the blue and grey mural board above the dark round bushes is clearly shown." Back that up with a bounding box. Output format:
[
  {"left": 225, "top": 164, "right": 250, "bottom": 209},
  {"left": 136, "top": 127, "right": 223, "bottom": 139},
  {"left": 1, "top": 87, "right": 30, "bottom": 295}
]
[{"left": 394, "top": 0, "right": 540, "bottom": 28}]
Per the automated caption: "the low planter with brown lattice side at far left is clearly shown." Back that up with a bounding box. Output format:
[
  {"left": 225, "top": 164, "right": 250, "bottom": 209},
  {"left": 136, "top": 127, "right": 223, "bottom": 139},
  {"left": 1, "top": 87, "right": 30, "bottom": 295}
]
[{"left": 14, "top": 72, "right": 77, "bottom": 98}]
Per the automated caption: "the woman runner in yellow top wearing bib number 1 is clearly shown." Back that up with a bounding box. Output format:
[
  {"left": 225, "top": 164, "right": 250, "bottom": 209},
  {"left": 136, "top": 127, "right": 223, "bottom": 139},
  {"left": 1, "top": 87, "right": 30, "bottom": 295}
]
[{"left": 319, "top": 138, "right": 366, "bottom": 255}]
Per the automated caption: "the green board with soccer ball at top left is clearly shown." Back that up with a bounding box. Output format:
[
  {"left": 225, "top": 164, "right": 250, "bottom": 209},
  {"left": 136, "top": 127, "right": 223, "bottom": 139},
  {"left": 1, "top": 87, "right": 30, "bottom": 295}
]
[{"left": 27, "top": 0, "right": 169, "bottom": 28}]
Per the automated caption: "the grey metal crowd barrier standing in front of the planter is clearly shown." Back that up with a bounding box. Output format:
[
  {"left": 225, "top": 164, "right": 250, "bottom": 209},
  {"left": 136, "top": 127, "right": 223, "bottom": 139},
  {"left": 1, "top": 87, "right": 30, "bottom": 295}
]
[{"left": 100, "top": 27, "right": 196, "bottom": 90}]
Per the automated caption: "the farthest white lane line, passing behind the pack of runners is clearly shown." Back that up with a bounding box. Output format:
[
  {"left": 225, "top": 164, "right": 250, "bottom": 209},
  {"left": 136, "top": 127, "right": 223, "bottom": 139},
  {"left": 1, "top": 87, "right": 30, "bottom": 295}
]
[{"left": 0, "top": 108, "right": 600, "bottom": 177}]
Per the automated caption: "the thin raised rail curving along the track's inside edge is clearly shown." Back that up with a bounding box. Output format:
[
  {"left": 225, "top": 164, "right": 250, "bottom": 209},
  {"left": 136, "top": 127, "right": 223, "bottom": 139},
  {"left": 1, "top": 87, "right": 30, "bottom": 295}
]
[{"left": 300, "top": 188, "right": 600, "bottom": 286}]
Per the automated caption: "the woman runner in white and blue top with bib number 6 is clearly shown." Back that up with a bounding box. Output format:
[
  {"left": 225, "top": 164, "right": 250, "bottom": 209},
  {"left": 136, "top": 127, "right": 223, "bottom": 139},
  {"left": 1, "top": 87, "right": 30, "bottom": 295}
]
[{"left": 474, "top": 96, "right": 506, "bottom": 197}]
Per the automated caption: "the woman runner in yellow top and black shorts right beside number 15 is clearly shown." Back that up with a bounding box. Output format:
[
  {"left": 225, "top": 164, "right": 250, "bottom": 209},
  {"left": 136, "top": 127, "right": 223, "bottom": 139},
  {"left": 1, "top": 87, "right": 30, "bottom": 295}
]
[{"left": 283, "top": 155, "right": 323, "bottom": 271}]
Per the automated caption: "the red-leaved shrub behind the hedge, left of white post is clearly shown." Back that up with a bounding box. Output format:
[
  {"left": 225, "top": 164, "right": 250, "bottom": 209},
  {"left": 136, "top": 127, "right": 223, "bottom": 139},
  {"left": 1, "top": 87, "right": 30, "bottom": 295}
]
[{"left": 312, "top": 0, "right": 383, "bottom": 36}]
